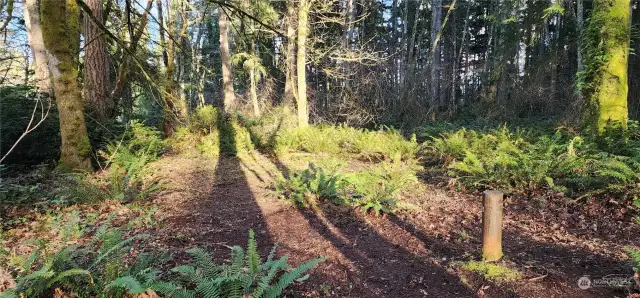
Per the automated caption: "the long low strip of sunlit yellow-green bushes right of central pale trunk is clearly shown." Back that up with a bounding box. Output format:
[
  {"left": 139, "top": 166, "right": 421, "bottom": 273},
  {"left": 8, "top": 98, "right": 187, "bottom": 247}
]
[{"left": 275, "top": 125, "right": 418, "bottom": 161}]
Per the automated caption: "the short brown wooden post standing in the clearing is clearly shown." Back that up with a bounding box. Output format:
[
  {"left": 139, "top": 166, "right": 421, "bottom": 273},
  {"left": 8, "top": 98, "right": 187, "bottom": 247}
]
[{"left": 482, "top": 190, "right": 503, "bottom": 262}]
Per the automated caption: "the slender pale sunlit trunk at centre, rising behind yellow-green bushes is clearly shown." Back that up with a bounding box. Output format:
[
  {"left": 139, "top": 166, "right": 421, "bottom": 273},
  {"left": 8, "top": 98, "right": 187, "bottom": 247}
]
[{"left": 297, "top": 0, "right": 310, "bottom": 128}]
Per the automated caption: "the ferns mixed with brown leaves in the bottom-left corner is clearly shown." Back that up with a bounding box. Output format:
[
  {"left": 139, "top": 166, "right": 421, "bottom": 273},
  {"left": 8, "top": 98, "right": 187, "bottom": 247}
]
[{"left": 0, "top": 226, "right": 162, "bottom": 298}]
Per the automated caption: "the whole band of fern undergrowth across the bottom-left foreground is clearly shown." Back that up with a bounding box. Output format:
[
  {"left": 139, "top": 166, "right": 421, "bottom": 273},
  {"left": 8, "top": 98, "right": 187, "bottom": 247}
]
[{"left": 0, "top": 226, "right": 325, "bottom": 298}]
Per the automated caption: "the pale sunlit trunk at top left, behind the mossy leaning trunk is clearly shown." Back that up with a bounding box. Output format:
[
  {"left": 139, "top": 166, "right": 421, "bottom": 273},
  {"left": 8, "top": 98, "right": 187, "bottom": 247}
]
[{"left": 24, "top": 0, "right": 53, "bottom": 95}]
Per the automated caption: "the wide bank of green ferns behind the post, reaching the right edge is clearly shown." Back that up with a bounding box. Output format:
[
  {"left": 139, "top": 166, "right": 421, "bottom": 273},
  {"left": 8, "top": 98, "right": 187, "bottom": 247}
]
[{"left": 422, "top": 126, "right": 640, "bottom": 195}]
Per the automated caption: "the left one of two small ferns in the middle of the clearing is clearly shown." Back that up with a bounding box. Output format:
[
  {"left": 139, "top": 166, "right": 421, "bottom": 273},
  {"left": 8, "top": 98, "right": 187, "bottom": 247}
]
[{"left": 276, "top": 163, "right": 347, "bottom": 206}]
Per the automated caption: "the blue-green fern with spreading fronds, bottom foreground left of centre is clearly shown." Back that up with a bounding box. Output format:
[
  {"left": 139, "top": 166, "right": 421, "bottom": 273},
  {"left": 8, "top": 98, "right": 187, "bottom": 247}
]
[{"left": 160, "top": 230, "right": 325, "bottom": 298}]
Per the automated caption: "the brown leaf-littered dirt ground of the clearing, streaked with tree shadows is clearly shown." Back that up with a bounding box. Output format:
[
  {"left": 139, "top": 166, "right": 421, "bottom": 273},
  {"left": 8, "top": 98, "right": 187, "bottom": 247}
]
[{"left": 145, "top": 152, "right": 640, "bottom": 297}]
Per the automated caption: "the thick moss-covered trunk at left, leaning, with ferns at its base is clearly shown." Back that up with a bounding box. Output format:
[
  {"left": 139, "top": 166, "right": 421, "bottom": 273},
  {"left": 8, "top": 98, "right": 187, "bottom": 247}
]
[{"left": 41, "top": 0, "right": 91, "bottom": 170}]
